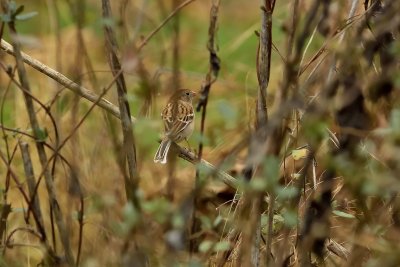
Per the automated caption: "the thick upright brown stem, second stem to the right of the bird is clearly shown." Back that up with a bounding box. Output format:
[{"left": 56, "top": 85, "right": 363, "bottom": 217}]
[{"left": 241, "top": 0, "right": 275, "bottom": 266}]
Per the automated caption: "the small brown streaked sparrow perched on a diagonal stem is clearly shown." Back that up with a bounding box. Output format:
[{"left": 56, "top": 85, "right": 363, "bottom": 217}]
[{"left": 154, "top": 89, "right": 196, "bottom": 164}]
